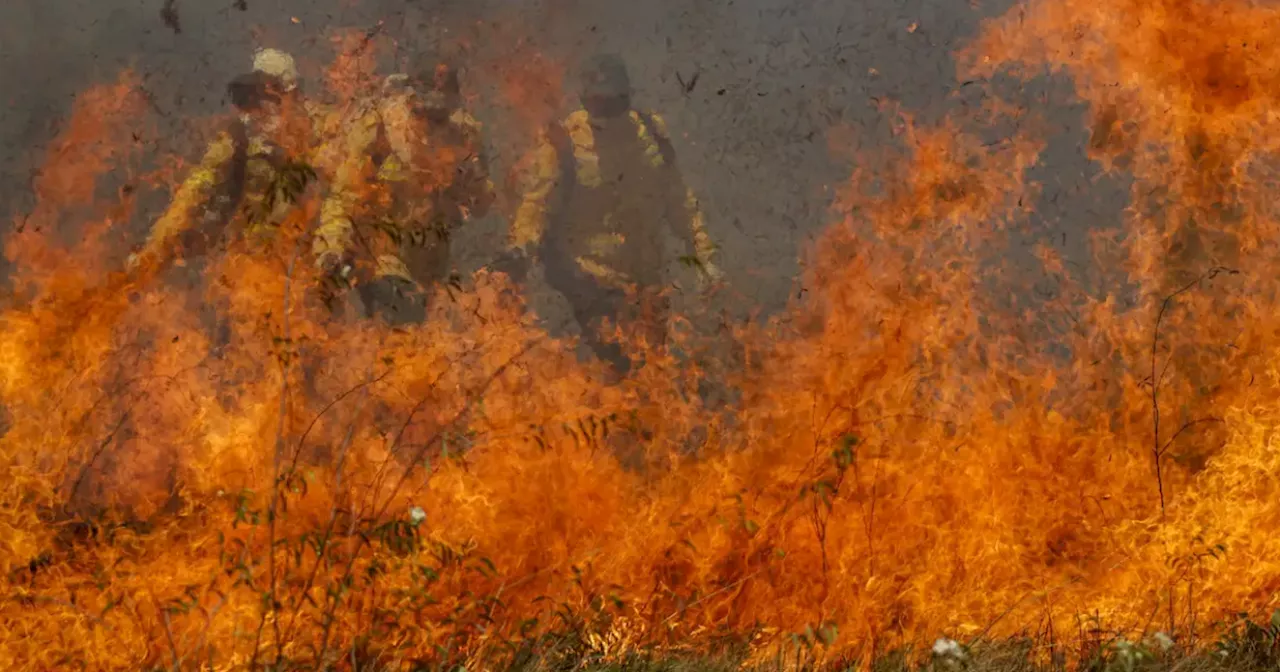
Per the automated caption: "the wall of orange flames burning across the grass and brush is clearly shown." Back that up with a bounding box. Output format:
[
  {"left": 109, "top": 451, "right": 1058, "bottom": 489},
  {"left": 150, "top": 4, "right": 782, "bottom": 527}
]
[{"left": 0, "top": 1, "right": 1280, "bottom": 672}]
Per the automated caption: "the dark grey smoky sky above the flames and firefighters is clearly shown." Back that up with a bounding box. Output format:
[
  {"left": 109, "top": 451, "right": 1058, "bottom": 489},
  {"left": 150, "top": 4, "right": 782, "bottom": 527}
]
[{"left": 0, "top": 0, "right": 1120, "bottom": 320}]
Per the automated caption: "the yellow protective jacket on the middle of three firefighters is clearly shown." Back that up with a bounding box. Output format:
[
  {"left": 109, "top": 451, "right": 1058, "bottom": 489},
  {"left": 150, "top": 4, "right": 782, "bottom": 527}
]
[{"left": 314, "top": 96, "right": 494, "bottom": 283}]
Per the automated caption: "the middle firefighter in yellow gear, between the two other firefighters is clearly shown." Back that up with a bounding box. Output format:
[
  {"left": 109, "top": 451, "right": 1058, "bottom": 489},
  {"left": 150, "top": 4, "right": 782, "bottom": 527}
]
[{"left": 314, "top": 65, "right": 494, "bottom": 324}]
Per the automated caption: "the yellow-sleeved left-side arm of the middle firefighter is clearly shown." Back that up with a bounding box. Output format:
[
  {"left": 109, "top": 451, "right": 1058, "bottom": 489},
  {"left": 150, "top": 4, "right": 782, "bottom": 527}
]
[{"left": 311, "top": 111, "right": 379, "bottom": 270}]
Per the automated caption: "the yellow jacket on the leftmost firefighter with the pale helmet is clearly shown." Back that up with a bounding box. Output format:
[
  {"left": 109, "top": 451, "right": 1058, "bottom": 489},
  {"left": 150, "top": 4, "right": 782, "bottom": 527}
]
[{"left": 131, "top": 102, "right": 334, "bottom": 266}]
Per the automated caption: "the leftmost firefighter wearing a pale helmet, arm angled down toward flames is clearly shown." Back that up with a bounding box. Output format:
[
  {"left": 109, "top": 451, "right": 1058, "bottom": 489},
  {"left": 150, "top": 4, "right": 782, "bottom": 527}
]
[{"left": 129, "top": 49, "right": 317, "bottom": 275}]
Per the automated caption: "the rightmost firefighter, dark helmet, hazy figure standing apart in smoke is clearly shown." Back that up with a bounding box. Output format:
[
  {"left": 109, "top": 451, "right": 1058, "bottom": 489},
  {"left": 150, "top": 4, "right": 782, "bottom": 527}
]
[{"left": 508, "top": 55, "right": 721, "bottom": 372}]
